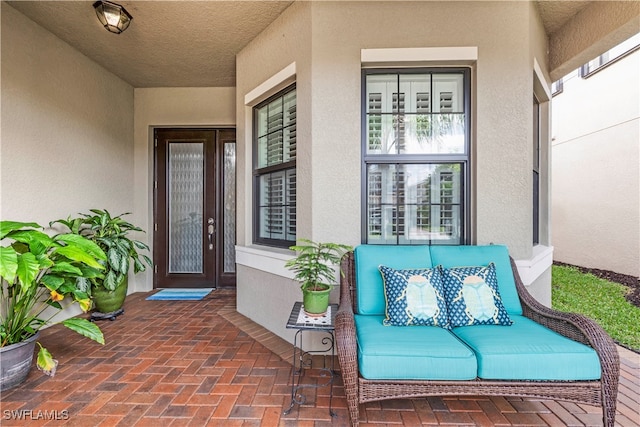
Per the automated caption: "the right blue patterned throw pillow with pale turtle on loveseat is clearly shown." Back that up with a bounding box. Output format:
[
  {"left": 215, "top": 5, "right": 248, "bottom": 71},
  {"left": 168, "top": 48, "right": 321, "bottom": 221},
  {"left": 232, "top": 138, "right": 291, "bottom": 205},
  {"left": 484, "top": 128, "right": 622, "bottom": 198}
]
[{"left": 442, "top": 263, "right": 513, "bottom": 327}]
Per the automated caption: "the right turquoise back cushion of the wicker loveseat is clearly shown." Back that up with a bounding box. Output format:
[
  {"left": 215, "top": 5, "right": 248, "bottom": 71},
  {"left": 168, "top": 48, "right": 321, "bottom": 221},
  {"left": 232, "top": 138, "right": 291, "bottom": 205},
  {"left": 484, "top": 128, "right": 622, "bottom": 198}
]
[{"left": 431, "top": 245, "right": 522, "bottom": 315}]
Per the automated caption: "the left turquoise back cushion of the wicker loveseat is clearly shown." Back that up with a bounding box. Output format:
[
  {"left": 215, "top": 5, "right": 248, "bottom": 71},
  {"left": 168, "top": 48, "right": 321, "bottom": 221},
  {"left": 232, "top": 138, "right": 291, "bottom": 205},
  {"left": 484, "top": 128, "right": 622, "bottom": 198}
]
[{"left": 354, "top": 245, "right": 433, "bottom": 315}]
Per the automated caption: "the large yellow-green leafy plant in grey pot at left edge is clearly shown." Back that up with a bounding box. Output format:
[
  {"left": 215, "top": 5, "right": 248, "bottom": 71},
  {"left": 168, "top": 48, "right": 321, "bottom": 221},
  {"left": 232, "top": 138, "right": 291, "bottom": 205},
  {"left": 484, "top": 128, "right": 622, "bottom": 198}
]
[{"left": 0, "top": 221, "right": 106, "bottom": 390}]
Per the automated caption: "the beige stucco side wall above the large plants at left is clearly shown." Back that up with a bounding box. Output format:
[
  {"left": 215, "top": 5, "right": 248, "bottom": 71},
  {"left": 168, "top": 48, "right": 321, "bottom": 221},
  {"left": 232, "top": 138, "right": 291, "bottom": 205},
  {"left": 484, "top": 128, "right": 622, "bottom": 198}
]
[{"left": 0, "top": 2, "right": 133, "bottom": 225}]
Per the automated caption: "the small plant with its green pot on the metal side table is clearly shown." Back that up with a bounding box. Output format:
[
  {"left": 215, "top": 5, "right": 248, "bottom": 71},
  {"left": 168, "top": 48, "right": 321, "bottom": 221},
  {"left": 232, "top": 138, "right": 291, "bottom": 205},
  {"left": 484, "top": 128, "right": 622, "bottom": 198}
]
[{"left": 285, "top": 239, "right": 352, "bottom": 316}]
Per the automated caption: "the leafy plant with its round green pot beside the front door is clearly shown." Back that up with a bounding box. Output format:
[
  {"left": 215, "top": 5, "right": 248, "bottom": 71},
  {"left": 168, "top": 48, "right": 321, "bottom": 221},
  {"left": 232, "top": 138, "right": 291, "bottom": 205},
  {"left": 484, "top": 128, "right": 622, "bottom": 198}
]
[{"left": 54, "top": 209, "right": 151, "bottom": 319}]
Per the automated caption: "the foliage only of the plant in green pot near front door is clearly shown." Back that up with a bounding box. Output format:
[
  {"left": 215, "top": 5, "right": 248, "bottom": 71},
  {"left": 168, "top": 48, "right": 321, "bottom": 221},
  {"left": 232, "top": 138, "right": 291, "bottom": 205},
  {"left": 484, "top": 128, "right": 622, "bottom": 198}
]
[{"left": 52, "top": 209, "right": 151, "bottom": 291}]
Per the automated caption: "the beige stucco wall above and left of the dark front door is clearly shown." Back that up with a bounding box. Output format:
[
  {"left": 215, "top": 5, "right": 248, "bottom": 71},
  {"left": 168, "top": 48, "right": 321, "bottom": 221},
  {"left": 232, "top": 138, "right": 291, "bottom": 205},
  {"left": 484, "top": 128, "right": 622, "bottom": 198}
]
[{"left": 133, "top": 87, "right": 236, "bottom": 292}]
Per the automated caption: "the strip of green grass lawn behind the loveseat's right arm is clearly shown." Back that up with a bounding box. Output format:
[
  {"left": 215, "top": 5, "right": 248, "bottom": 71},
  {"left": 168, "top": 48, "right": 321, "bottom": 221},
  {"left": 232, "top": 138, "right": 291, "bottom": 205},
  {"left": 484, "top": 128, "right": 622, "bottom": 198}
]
[{"left": 551, "top": 265, "right": 640, "bottom": 351}]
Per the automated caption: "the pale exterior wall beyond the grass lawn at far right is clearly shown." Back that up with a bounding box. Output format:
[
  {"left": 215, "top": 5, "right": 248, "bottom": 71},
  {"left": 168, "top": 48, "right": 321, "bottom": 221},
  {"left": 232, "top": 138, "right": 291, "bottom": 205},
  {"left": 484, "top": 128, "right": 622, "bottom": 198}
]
[{"left": 552, "top": 51, "right": 640, "bottom": 277}]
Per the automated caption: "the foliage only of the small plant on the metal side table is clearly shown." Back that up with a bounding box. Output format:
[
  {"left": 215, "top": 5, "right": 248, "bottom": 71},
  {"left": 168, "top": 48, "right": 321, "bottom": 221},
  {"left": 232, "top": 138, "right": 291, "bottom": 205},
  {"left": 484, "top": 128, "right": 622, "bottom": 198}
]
[{"left": 285, "top": 239, "right": 352, "bottom": 290}]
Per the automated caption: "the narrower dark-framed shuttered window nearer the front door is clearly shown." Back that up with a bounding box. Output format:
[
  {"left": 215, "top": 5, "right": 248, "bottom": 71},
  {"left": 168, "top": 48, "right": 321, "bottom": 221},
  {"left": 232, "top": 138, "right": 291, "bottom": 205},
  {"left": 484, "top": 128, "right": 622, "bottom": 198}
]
[{"left": 253, "top": 86, "right": 296, "bottom": 247}]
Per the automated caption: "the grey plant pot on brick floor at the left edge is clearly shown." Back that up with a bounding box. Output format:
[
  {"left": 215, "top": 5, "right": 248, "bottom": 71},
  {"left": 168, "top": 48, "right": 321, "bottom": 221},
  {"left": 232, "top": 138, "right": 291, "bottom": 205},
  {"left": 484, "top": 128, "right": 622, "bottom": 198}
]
[{"left": 0, "top": 332, "right": 40, "bottom": 391}]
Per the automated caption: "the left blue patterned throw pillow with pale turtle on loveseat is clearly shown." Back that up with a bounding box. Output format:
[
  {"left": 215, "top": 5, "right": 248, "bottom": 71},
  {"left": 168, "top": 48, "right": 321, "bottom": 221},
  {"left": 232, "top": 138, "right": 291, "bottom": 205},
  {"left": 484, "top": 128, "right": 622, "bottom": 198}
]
[{"left": 378, "top": 265, "right": 449, "bottom": 328}]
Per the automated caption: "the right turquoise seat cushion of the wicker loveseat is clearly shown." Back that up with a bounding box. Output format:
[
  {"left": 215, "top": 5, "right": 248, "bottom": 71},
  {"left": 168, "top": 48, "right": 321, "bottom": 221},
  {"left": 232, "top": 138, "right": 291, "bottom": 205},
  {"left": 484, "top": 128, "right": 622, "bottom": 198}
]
[{"left": 453, "top": 315, "right": 601, "bottom": 381}]
